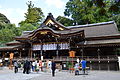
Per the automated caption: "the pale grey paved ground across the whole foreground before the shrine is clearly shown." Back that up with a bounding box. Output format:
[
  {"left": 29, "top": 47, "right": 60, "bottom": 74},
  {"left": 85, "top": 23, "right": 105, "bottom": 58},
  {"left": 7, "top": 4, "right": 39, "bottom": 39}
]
[{"left": 0, "top": 68, "right": 120, "bottom": 80}]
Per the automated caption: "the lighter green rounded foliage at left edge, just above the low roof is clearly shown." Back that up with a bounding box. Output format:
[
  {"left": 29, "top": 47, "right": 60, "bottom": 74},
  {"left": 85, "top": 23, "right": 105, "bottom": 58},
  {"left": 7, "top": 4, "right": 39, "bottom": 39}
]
[{"left": 0, "top": 23, "right": 20, "bottom": 43}]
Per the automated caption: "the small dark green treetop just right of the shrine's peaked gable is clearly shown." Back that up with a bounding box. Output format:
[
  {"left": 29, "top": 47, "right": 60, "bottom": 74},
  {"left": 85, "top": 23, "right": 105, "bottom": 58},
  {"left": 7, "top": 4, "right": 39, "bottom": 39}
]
[{"left": 56, "top": 16, "right": 74, "bottom": 26}]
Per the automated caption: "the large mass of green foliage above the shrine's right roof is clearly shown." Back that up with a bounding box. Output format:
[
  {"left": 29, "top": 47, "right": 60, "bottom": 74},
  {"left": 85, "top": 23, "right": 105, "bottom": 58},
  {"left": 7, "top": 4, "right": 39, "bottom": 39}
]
[{"left": 64, "top": 0, "right": 120, "bottom": 24}]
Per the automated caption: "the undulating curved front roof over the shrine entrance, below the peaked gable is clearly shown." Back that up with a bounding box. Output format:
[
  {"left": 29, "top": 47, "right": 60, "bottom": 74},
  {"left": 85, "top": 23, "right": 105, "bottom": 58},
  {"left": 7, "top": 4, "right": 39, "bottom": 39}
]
[{"left": 15, "top": 26, "right": 84, "bottom": 40}]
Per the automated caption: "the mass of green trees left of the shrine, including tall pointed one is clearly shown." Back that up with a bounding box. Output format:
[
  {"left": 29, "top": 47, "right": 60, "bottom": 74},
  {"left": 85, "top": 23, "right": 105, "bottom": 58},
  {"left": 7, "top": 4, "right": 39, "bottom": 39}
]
[{"left": 0, "top": 1, "right": 44, "bottom": 44}]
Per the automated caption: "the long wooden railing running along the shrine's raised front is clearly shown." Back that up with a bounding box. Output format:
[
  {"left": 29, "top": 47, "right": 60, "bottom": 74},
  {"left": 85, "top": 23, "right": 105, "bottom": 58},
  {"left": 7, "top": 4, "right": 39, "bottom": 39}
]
[{"left": 4, "top": 55, "right": 118, "bottom": 61}]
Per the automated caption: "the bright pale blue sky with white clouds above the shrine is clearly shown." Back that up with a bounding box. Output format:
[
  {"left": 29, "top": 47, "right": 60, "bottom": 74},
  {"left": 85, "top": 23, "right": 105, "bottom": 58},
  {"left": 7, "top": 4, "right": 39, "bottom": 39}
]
[{"left": 0, "top": 0, "right": 69, "bottom": 26}]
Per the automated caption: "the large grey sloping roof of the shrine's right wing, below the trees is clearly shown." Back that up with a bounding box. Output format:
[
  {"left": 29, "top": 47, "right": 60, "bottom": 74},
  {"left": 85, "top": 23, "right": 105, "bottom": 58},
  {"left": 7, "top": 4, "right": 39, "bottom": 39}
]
[{"left": 67, "top": 21, "right": 119, "bottom": 37}]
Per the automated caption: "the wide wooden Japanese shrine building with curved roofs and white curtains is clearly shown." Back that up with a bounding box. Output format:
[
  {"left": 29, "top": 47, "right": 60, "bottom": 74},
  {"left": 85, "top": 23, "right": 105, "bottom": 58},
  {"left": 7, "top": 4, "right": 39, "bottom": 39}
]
[{"left": 0, "top": 13, "right": 120, "bottom": 70}]
